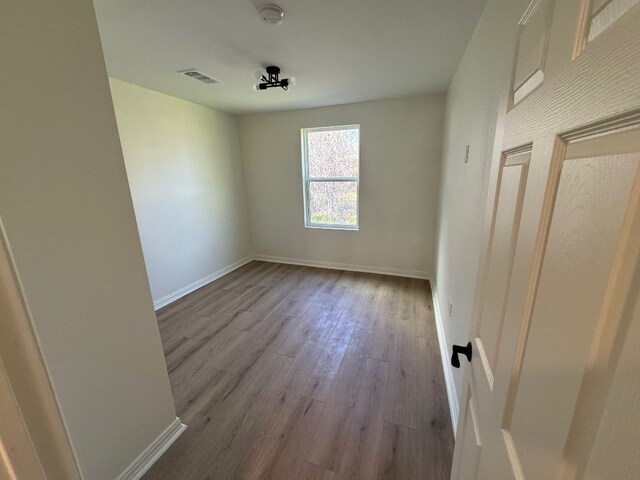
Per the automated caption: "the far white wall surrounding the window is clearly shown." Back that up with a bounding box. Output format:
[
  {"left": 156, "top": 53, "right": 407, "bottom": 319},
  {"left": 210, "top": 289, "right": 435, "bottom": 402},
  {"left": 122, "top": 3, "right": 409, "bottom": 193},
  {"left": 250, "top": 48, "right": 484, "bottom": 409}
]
[{"left": 240, "top": 95, "right": 445, "bottom": 273}]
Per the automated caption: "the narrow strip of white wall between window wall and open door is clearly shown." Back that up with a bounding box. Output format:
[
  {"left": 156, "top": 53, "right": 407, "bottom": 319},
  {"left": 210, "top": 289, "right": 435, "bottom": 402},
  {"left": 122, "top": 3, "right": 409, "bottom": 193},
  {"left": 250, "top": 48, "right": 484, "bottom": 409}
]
[{"left": 435, "top": 0, "right": 528, "bottom": 412}]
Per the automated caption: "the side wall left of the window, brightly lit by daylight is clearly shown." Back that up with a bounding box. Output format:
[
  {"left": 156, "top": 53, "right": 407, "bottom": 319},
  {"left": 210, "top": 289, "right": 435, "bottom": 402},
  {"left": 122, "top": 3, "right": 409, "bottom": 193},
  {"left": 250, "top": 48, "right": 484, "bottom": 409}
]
[{"left": 110, "top": 79, "right": 251, "bottom": 301}]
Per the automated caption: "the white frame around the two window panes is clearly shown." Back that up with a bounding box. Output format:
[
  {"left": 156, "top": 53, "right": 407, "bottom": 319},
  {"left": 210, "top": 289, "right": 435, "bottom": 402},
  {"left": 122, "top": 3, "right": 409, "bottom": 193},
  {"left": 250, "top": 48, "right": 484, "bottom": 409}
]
[{"left": 300, "top": 124, "right": 361, "bottom": 230}]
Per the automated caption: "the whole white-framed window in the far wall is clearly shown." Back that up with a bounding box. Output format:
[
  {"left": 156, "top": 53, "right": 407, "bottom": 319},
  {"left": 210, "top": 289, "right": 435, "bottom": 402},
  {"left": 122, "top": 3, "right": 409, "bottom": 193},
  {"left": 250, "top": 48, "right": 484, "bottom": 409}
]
[{"left": 302, "top": 125, "right": 360, "bottom": 230}]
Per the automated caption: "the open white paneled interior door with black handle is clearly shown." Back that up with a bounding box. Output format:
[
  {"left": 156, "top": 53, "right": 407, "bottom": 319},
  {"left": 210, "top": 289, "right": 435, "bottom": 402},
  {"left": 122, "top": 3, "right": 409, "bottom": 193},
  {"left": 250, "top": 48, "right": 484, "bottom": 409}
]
[{"left": 452, "top": 0, "right": 640, "bottom": 480}]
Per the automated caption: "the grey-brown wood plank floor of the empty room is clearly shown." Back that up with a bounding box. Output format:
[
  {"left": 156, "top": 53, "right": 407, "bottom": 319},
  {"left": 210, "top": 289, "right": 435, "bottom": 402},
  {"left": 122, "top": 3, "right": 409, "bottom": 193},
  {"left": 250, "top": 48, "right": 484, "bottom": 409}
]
[{"left": 144, "top": 262, "right": 453, "bottom": 480}]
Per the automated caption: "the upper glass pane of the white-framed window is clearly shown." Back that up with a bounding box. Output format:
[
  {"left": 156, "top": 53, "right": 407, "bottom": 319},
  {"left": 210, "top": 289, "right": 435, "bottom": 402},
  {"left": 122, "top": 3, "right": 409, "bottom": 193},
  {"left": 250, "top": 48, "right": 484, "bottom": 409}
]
[{"left": 307, "top": 128, "right": 360, "bottom": 177}]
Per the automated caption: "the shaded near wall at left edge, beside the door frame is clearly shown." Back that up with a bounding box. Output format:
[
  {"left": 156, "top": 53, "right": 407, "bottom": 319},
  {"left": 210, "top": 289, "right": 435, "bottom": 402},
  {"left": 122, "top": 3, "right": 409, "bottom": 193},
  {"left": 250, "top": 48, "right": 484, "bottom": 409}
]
[{"left": 0, "top": 0, "right": 175, "bottom": 480}]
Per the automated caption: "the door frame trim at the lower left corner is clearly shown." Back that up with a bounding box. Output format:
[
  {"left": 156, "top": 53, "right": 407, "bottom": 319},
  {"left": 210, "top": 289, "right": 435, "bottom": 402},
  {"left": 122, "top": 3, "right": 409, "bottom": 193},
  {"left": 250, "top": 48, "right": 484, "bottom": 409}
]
[{"left": 0, "top": 218, "right": 82, "bottom": 480}]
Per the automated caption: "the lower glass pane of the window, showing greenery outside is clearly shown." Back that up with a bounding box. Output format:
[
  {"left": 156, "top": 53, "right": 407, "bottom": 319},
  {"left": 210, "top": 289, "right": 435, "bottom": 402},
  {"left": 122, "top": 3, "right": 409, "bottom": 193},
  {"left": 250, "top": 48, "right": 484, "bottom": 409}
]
[{"left": 309, "top": 181, "right": 358, "bottom": 227}]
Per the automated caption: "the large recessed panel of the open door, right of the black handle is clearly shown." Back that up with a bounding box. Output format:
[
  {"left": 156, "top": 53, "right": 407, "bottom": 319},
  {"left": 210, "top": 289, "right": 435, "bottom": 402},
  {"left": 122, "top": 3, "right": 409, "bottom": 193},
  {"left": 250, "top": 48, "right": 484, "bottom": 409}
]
[{"left": 503, "top": 132, "right": 640, "bottom": 478}]
